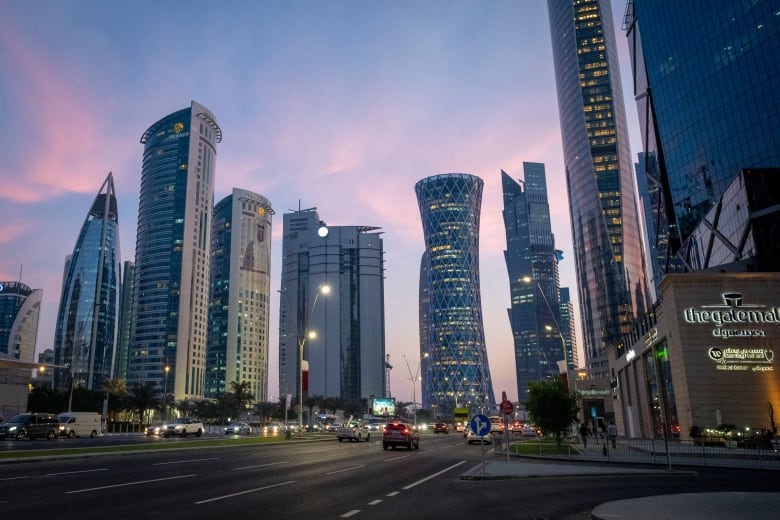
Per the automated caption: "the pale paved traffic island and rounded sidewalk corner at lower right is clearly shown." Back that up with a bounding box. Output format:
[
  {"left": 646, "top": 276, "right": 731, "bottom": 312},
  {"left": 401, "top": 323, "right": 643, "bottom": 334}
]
[{"left": 460, "top": 459, "right": 780, "bottom": 520}]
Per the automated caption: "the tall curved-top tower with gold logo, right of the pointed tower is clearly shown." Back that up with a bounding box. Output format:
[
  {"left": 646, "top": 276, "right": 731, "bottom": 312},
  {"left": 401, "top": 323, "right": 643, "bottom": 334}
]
[{"left": 127, "top": 101, "right": 222, "bottom": 400}]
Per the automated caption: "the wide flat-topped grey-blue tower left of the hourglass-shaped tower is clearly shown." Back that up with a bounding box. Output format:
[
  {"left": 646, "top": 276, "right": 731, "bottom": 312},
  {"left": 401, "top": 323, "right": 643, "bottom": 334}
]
[{"left": 279, "top": 208, "right": 386, "bottom": 411}]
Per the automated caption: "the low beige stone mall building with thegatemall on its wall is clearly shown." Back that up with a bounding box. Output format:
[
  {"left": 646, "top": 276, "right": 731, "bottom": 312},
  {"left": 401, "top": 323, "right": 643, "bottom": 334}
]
[{"left": 610, "top": 272, "right": 780, "bottom": 440}]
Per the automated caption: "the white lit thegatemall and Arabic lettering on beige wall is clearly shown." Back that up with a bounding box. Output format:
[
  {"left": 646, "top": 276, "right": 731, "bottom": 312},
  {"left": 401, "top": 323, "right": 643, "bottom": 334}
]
[{"left": 683, "top": 292, "right": 780, "bottom": 372}]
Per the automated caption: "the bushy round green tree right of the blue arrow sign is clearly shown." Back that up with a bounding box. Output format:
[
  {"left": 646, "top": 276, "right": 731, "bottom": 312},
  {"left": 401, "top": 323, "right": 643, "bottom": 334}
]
[{"left": 523, "top": 379, "right": 578, "bottom": 445}]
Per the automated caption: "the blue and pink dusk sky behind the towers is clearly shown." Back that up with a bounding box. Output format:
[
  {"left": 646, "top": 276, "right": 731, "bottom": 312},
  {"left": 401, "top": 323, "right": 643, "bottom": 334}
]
[{"left": 0, "top": 0, "right": 640, "bottom": 401}]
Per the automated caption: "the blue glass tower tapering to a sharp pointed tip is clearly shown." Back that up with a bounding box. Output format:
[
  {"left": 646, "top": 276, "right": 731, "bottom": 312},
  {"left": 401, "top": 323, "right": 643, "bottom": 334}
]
[{"left": 54, "top": 173, "right": 121, "bottom": 390}]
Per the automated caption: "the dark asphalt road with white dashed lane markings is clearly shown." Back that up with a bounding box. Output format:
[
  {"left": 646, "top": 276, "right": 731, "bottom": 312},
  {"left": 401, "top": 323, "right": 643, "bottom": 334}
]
[{"left": 0, "top": 435, "right": 777, "bottom": 520}]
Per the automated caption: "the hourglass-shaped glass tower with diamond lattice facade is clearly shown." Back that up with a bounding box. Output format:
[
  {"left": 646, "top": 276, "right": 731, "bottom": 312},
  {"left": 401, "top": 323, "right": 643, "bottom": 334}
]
[{"left": 414, "top": 173, "right": 495, "bottom": 417}]
